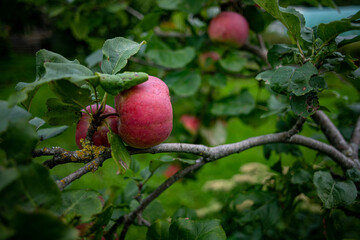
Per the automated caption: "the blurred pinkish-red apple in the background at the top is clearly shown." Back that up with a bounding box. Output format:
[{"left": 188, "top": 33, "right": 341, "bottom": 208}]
[{"left": 208, "top": 12, "right": 249, "bottom": 47}]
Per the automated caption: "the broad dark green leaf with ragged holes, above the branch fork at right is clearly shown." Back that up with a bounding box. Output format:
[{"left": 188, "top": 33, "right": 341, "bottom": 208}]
[{"left": 269, "top": 62, "right": 318, "bottom": 96}]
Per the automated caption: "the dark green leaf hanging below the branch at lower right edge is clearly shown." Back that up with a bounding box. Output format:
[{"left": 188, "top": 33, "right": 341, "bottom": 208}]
[{"left": 313, "top": 171, "right": 357, "bottom": 208}]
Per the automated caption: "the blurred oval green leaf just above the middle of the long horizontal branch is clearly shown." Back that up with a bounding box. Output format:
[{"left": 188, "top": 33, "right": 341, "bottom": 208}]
[{"left": 210, "top": 89, "right": 255, "bottom": 116}]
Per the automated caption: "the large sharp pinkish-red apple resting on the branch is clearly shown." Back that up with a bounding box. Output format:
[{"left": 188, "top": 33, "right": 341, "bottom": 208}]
[{"left": 115, "top": 76, "right": 173, "bottom": 148}]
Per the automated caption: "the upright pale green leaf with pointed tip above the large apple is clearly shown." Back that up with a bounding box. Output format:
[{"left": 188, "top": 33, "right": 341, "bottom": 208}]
[{"left": 101, "top": 37, "right": 145, "bottom": 74}]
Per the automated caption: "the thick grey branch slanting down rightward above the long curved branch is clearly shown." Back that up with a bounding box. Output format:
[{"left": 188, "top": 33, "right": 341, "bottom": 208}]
[{"left": 312, "top": 111, "right": 352, "bottom": 157}]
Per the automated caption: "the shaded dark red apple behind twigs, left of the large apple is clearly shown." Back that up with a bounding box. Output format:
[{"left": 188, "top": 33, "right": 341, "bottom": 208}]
[{"left": 75, "top": 104, "right": 119, "bottom": 149}]
